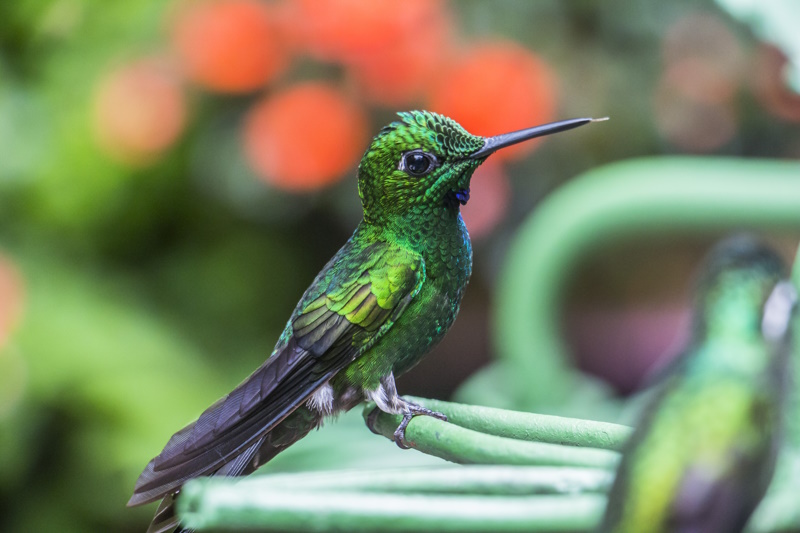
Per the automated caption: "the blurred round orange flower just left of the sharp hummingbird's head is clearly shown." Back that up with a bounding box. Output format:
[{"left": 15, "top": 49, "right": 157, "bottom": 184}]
[{"left": 244, "top": 82, "right": 367, "bottom": 191}]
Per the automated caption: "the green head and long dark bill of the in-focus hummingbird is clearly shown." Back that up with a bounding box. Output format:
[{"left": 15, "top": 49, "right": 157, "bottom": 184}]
[{"left": 358, "top": 111, "right": 593, "bottom": 222}]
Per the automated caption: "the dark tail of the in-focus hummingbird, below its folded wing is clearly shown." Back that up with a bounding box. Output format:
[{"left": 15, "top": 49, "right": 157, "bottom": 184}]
[{"left": 147, "top": 406, "right": 322, "bottom": 533}]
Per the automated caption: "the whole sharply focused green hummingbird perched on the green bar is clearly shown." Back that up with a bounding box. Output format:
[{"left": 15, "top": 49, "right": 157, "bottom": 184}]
[{"left": 128, "top": 111, "right": 599, "bottom": 533}]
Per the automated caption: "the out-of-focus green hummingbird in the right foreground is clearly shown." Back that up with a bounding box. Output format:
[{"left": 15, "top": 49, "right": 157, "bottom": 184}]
[{"left": 600, "top": 237, "right": 796, "bottom": 533}]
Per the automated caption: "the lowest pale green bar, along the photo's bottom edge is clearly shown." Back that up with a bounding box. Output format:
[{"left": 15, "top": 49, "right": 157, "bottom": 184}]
[{"left": 178, "top": 486, "right": 606, "bottom": 533}]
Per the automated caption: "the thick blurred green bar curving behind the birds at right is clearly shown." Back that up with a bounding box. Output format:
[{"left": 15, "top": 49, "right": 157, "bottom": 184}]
[{"left": 476, "top": 157, "right": 800, "bottom": 410}]
